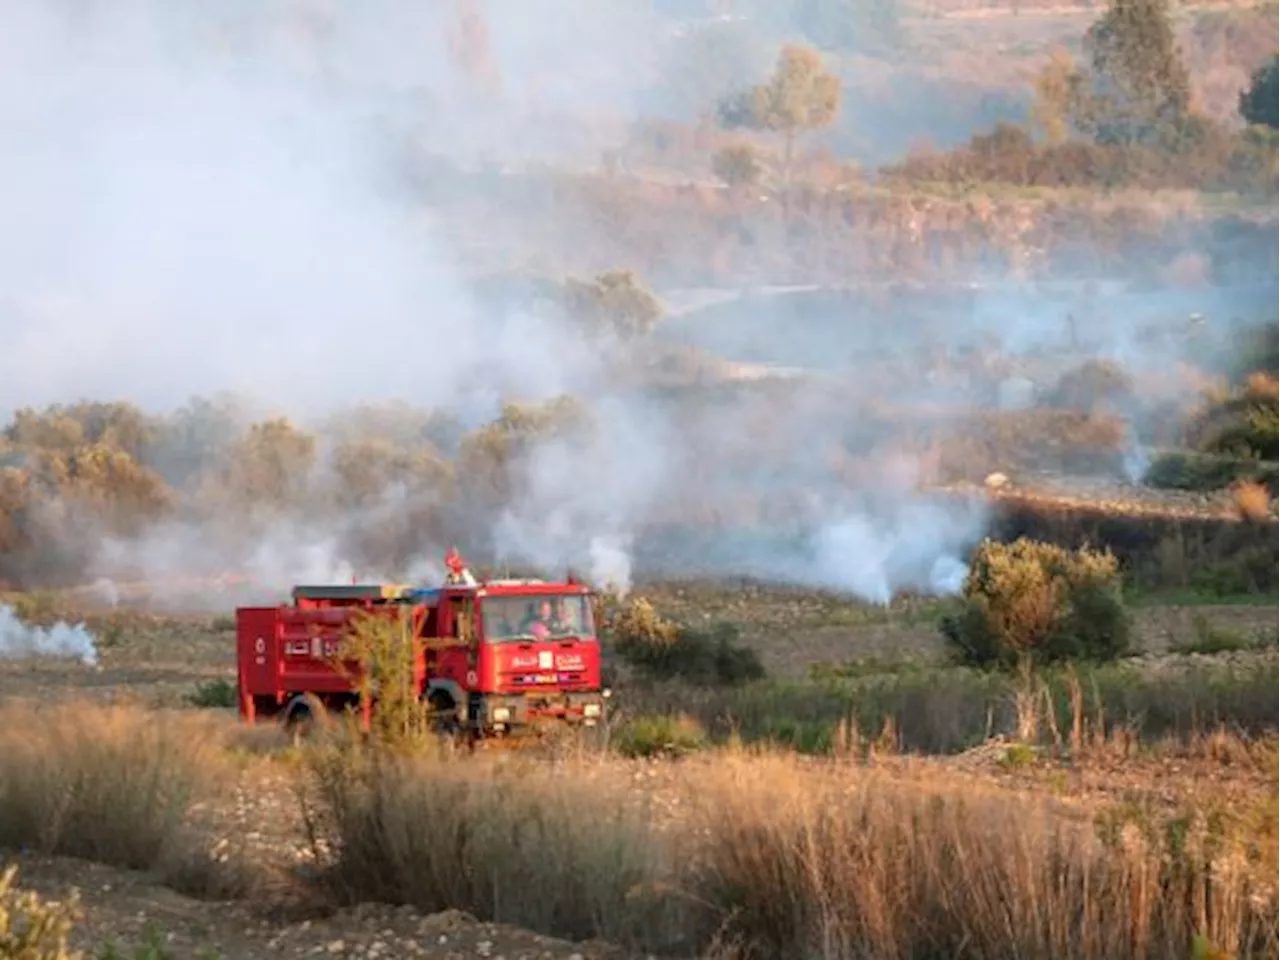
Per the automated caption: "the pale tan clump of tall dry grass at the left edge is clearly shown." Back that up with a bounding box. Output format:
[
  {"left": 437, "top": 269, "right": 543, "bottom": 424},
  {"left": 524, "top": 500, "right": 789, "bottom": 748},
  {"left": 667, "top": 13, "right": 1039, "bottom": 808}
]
[{"left": 0, "top": 700, "right": 238, "bottom": 893}]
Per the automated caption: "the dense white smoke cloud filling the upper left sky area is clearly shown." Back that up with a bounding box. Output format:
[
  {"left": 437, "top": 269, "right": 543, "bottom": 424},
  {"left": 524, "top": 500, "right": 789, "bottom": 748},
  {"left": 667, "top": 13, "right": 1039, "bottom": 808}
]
[{"left": 0, "top": 3, "right": 606, "bottom": 415}]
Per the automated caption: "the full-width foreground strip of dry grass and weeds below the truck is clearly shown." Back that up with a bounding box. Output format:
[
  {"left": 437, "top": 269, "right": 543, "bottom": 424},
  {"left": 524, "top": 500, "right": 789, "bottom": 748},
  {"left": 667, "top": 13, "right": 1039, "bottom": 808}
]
[{"left": 0, "top": 704, "right": 1280, "bottom": 960}]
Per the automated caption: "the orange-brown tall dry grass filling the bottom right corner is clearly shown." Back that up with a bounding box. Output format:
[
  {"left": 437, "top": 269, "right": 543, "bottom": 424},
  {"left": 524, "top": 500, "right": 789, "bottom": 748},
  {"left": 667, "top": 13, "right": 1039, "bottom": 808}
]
[{"left": 696, "top": 759, "right": 1280, "bottom": 960}]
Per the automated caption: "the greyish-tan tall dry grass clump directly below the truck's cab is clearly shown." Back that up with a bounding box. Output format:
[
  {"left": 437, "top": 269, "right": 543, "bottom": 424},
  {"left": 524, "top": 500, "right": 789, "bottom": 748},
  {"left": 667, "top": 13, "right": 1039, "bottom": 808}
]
[{"left": 298, "top": 742, "right": 684, "bottom": 948}]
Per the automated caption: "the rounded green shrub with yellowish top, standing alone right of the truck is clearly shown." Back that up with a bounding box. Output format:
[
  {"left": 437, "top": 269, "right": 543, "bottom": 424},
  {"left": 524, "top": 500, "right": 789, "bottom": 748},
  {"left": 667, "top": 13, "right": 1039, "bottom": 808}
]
[{"left": 940, "top": 538, "right": 1130, "bottom": 668}]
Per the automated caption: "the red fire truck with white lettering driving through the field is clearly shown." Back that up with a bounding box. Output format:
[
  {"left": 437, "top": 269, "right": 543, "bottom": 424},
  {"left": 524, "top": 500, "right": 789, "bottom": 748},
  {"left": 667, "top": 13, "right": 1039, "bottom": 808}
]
[{"left": 236, "top": 550, "right": 609, "bottom": 737}]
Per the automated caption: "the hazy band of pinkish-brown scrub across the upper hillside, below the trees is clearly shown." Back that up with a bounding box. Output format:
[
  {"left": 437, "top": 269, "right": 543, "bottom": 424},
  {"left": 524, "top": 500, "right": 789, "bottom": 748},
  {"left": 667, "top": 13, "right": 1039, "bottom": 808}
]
[{"left": 442, "top": 161, "right": 1280, "bottom": 287}]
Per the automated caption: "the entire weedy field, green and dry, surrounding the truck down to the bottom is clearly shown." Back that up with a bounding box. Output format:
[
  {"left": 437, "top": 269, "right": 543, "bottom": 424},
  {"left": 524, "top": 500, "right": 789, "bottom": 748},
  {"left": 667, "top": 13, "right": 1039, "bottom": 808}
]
[{"left": 0, "top": 560, "right": 1280, "bottom": 960}]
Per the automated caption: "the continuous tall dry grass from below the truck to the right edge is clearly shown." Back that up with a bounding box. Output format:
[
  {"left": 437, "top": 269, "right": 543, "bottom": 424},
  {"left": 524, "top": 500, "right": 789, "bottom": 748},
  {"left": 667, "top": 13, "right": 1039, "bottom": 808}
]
[{"left": 302, "top": 751, "right": 1280, "bottom": 960}]
